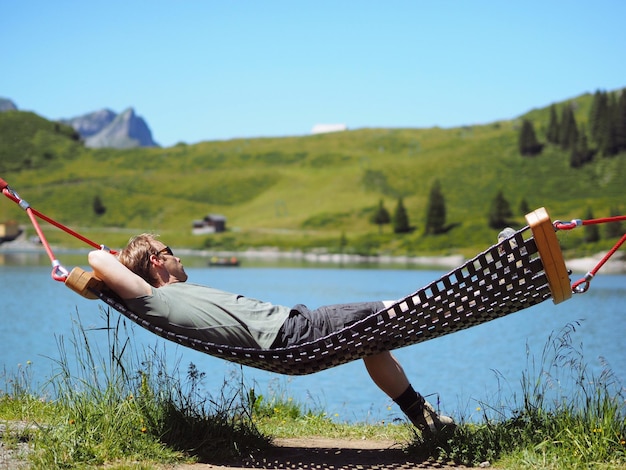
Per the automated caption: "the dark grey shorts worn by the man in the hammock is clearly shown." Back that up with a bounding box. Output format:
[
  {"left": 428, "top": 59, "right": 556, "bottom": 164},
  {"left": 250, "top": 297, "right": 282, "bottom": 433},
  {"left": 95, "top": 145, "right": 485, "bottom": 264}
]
[{"left": 271, "top": 302, "right": 385, "bottom": 348}]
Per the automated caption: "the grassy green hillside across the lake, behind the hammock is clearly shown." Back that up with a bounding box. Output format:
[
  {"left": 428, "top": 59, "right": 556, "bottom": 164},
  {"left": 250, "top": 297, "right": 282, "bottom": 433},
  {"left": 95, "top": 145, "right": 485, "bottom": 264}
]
[{"left": 0, "top": 94, "right": 626, "bottom": 254}]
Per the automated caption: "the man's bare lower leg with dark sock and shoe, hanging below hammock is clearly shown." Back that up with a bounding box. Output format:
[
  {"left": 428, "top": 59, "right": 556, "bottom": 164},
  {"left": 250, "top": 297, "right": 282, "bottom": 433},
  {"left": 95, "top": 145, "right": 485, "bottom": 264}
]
[{"left": 363, "top": 351, "right": 454, "bottom": 435}]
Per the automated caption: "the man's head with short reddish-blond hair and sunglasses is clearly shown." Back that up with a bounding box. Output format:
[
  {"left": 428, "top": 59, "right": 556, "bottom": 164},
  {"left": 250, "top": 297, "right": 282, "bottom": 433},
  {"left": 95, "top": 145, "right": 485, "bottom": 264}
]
[{"left": 118, "top": 233, "right": 187, "bottom": 287}]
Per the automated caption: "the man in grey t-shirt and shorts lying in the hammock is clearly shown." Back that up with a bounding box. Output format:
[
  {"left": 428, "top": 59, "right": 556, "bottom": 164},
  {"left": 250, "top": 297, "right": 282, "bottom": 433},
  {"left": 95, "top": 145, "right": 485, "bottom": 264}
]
[{"left": 89, "top": 234, "right": 454, "bottom": 435}]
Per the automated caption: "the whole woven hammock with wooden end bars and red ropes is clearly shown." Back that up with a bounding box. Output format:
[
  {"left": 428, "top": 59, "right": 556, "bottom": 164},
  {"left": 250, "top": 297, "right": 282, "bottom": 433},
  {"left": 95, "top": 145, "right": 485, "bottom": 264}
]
[{"left": 7, "top": 178, "right": 626, "bottom": 375}]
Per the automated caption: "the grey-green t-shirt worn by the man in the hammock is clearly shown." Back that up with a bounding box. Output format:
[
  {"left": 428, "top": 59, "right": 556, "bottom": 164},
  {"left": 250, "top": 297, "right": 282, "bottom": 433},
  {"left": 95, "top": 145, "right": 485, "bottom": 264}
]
[{"left": 125, "top": 282, "right": 291, "bottom": 349}]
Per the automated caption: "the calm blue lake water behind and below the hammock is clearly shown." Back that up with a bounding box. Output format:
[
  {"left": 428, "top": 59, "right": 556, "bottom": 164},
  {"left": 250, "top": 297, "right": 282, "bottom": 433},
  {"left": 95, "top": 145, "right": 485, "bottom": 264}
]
[{"left": 0, "top": 255, "right": 626, "bottom": 422}]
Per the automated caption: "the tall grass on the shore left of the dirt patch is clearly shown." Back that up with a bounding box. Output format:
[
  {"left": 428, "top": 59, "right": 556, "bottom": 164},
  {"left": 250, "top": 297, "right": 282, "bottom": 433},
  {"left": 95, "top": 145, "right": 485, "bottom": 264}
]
[{"left": 3, "top": 311, "right": 269, "bottom": 469}]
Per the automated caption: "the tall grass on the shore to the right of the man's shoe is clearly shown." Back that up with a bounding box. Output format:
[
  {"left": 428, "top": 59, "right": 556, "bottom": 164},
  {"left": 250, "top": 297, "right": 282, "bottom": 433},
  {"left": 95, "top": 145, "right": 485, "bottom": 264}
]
[{"left": 413, "top": 322, "right": 626, "bottom": 469}]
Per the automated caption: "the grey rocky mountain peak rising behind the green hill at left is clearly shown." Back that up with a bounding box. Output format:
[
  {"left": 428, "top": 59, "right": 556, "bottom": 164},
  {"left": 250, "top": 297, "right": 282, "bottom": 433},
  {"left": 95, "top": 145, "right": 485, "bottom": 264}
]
[{"left": 61, "top": 108, "right": 159, "bottom": 148}]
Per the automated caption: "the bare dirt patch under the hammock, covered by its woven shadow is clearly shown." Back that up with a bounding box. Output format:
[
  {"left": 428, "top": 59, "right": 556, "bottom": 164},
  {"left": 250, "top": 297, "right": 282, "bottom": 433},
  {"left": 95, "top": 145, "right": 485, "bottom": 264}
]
[{"left": 174, "top": 438, "right": 468, "bottom": 470}]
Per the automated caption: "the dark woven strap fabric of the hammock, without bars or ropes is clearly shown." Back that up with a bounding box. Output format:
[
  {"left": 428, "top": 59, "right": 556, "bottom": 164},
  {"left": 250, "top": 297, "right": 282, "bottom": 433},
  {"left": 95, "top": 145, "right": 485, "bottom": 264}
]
[{"left": 96, "top": 227, "right": 551, "bottom": 375}]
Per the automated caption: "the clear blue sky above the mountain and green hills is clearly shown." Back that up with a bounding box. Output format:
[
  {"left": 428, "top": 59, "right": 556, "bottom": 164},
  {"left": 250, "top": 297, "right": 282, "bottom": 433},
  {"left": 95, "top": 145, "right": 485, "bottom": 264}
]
[{"left": 0, "top": 0, "right": 626, "bottom": 146}]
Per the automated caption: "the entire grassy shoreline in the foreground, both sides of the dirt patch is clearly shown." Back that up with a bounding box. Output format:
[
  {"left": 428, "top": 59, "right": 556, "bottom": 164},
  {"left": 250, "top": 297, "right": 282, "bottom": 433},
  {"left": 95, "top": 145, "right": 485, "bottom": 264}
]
[{"left": 0, "top": 311, "right": 626, "bottom": 469}]
